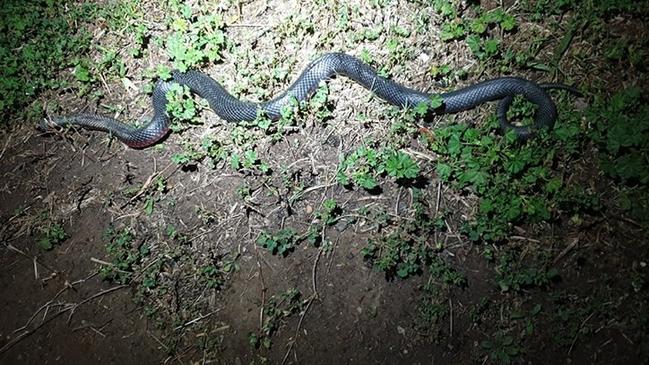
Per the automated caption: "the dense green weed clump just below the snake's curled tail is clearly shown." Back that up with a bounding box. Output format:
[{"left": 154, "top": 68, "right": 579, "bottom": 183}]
[{"left": 428, "top": 101, "right": 584, "bottom": 241}]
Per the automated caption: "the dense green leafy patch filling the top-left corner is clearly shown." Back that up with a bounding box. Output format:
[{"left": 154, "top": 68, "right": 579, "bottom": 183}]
[{"left": 0, "top": 0, "right": 138, "bottom": 123}]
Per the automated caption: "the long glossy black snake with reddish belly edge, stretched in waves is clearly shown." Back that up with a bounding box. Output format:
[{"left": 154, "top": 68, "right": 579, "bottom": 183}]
[{"left": 39, "top": 53, "right": 578, "bottom": 149}]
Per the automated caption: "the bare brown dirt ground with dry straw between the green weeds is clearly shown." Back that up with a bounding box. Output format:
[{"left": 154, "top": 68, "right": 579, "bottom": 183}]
[{"left": 0, "top": 1, "right": 649, "bottom": 364}]
